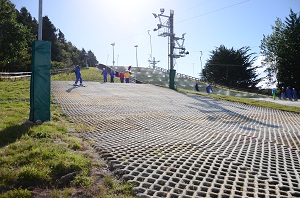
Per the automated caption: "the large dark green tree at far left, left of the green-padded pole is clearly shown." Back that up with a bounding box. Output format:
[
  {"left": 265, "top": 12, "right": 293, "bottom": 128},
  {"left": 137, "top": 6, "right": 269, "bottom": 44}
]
[{"left": 0, "top": 0, "right": 34, "bottom": 71}]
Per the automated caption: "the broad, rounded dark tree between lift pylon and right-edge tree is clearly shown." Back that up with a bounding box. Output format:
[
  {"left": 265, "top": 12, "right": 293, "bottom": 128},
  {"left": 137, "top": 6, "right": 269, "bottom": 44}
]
[{"left": 203, "top": 45, "right": 259, "bottom": 88}]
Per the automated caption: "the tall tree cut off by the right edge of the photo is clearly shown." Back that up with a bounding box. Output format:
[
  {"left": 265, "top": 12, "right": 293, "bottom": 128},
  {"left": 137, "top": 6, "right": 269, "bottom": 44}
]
[{"left": 260, "top": 10, "right": 300, "bottom": 90}]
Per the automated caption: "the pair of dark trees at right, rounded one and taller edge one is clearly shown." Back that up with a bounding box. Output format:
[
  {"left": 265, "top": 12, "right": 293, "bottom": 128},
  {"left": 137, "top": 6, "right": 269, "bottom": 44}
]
[{"left": 202, "top": 10, "right": 300, "bottom": 91}]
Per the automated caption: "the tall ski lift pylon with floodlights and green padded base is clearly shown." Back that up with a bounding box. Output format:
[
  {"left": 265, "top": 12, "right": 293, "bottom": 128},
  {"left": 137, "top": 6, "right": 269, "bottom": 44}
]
[{"left": 152, "top": 8, "right": 189, "bottom": 89}]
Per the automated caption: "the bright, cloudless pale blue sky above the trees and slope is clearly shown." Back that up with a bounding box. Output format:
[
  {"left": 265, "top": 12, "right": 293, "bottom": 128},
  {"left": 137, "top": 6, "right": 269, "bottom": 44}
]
[{"left": 11, "top": 0, "right": 300, "bottom": 76}]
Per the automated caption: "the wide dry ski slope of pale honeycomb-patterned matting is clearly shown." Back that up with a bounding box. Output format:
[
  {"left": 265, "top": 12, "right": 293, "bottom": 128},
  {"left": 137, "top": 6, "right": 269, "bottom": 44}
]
[{"left": 52, "top": 82, "right": 300, "bottom": 198}]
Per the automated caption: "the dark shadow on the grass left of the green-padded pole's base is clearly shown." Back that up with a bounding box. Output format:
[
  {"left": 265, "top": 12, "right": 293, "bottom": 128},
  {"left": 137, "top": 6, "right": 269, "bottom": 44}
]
[{"left": 0, "top": 122, "right": 34, "bottom": 148}]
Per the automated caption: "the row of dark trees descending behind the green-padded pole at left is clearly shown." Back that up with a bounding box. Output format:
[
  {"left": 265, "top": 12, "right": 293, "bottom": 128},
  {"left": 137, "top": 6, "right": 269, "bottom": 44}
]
[{"left": 0, "top": 0, "right": 98, "bottom": 71}]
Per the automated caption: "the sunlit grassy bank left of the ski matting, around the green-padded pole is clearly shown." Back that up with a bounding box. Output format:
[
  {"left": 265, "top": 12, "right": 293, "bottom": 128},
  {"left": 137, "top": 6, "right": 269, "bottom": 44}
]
[{"left": 0, "top": 79, "right": 132, "bottom": 198}]
